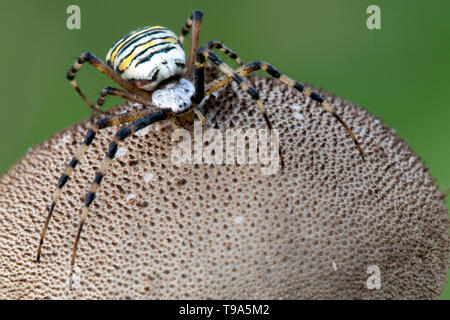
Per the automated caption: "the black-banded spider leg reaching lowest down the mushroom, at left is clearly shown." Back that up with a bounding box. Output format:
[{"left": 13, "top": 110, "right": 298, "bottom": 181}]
[{"left": 70, "top": 110, "right": 168, "bottom": 286}]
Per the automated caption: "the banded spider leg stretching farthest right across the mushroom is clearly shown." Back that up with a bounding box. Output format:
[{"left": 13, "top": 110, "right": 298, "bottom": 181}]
[{"left": 205, "top": 61, "right": 365, "bottom": 160}]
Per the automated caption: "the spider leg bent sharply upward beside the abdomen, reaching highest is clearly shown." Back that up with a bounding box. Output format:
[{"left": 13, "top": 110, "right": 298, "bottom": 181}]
[{"left": 178, "top": 10, "right": 203, "bottom": 78}]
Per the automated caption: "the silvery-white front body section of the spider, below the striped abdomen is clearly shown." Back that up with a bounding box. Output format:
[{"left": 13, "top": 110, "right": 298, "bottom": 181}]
[{"left": 152, "top": 78, "right": 195, "bottom": 113}]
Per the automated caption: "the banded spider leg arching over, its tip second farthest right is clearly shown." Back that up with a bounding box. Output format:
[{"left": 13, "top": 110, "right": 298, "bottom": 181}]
[{"left": 192, "top": 47, "right": 284, "bottom": 169}]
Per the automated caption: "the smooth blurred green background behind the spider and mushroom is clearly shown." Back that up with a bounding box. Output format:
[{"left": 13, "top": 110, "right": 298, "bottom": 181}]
[{"left": 0, "top": 0, "right": 450, "bottom": 299}]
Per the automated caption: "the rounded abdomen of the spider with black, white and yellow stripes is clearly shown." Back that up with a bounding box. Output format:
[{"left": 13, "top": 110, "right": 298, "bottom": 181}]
[{"left": 106, "top": 26, "right": 186, "bottom": 90}]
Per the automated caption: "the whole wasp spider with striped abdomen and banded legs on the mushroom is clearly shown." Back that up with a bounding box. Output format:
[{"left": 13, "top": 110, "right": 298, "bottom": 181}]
[{"left": 37, "top": 10, "right": 364, "bottom": 283}]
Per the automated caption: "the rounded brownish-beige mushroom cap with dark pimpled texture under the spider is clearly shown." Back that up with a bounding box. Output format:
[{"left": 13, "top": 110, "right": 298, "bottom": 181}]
[{"left": 0, "top": 73, "right": 449, "bottom": 299}]
